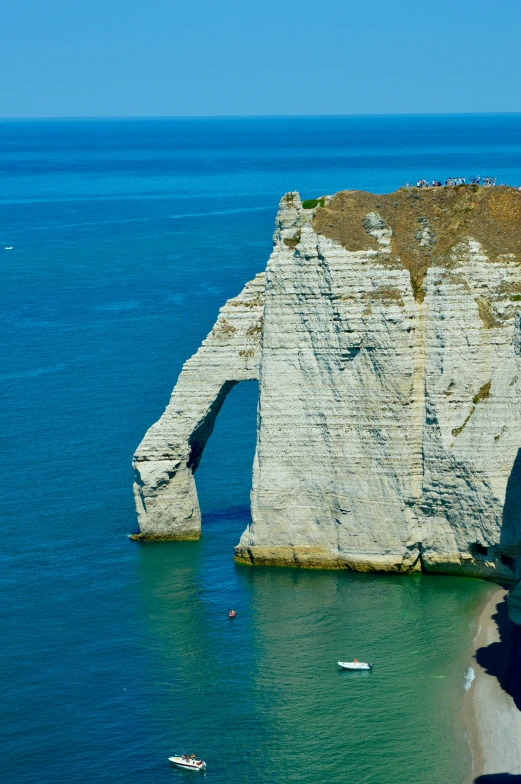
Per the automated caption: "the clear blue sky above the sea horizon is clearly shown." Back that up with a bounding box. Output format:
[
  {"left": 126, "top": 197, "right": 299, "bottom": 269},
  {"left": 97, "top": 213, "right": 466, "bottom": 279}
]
[{"left": 0, "top": 0, "right": 521, "bottom": 117}]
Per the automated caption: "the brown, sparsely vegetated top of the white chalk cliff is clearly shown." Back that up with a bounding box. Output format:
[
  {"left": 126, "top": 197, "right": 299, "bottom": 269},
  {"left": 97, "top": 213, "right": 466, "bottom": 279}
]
[{"left": 313, "top": 185, "right": 521, "bottom": 300}]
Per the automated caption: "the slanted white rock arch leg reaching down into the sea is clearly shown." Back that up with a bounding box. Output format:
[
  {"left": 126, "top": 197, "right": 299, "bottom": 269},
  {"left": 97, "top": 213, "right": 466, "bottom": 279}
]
[{"left": 133, "top": 273, "right": 264, "bottom": 539}]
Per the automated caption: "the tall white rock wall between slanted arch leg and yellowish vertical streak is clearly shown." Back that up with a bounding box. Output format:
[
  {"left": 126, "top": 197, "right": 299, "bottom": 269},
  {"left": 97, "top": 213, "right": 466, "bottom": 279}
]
[{"left": 236, "top": 195, "right": 423, "bottom": 571}]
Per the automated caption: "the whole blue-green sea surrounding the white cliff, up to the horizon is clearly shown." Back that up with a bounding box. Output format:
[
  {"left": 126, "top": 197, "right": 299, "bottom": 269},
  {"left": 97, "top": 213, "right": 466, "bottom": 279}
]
[{"left": 0, "top": 115, "right": 521, "bottom": 784}]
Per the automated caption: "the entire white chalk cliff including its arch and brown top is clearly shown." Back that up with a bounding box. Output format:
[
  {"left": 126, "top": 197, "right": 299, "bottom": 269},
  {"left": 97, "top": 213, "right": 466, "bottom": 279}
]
[{"left": 134, "top": 187, "right": 521, "bottom": 596}]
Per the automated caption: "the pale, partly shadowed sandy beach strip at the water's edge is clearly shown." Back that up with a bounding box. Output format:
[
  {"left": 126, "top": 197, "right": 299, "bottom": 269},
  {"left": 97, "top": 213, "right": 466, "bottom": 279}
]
[{"left": 464, "top": 586, "right": 521, "bottom": 784}]
